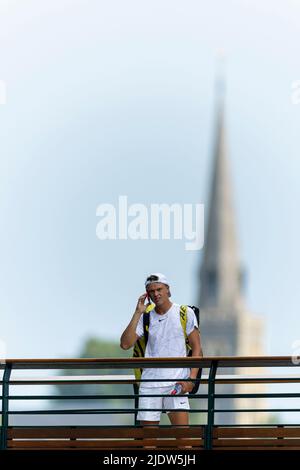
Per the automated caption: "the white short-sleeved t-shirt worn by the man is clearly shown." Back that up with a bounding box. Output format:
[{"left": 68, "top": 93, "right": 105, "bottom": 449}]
[{"left": 136, "top": 304, "right": 198, "bottom": 387}]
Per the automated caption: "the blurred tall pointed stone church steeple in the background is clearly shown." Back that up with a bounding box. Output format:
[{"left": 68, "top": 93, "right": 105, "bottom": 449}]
[{"left": 200, "top": 82, "right": 242, "bottom": 311}]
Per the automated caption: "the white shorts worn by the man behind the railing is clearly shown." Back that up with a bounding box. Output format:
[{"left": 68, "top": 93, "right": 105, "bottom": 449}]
[{"left": 137, "top": 385, "right": 190, "bottom": 421}]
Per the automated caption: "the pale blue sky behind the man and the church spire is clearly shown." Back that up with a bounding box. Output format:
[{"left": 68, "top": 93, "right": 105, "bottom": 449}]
[{"left": 0, "top": 0, "right": 300, "bottom": 357}]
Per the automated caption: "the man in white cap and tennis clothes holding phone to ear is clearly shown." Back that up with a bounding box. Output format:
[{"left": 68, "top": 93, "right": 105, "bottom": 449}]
[{"left": 121, "top": 273, "right": 203, "bottom": 425}]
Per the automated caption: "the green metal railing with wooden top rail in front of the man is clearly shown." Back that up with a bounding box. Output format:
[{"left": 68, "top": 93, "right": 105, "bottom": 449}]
[{"left": 0, "top": 357, "right": 300, "bottom": 449}]
